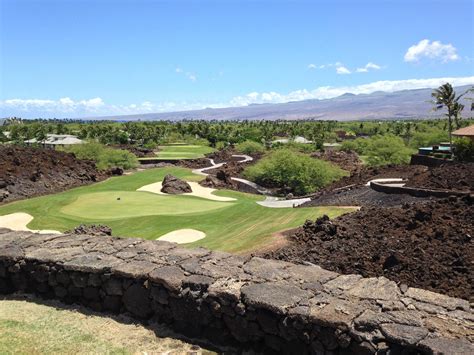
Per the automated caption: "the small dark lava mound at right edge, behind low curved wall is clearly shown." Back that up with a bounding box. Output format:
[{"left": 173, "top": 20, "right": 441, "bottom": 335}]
[{"left": 407, "top": 163, "right": 474, "bottom": 191}]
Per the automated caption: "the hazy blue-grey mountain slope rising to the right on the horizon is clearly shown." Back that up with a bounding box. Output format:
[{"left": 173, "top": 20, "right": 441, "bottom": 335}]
[{"left": 88, "top": 86, "right": 473, "bottom": 121}]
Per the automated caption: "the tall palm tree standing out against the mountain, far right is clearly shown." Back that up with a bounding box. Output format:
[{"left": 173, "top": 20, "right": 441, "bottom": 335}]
[{"left": 431, "top": 83, "right": 474, "bottom": 149}]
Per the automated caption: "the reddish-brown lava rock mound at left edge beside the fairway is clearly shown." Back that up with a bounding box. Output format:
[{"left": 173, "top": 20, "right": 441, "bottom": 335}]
[{"left": 0, "top": 145, "right": 106, "bottom": 202}]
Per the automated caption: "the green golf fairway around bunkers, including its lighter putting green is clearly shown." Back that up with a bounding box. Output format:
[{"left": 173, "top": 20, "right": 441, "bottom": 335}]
[{"left": 0, "top": 167, "right": 356, "bottom": 253}]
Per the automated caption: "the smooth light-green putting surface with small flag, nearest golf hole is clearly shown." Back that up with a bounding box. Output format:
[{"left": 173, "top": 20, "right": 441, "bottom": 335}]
[{"left": 61, "top": 191, "right": 231, "bottom": 220}]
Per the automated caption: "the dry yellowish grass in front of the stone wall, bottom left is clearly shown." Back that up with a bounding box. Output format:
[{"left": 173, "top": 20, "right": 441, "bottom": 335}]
[{"left": 0, "top": 298, "right": 213, "bottom": 355}]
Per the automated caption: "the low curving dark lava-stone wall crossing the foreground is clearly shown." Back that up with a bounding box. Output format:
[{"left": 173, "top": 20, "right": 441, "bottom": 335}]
[{"left": 0, "top": 229, "right": 474, "bottom": 354}]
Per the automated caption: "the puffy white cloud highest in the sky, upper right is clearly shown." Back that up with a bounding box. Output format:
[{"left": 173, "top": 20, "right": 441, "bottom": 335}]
[{"left": 404, "top": 39, "right": 459, "bottom": 63}]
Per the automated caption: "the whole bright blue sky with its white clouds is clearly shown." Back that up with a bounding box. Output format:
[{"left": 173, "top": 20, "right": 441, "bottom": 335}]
[{"left": 0, "top": 0, "right": 474, "bottom": 118}]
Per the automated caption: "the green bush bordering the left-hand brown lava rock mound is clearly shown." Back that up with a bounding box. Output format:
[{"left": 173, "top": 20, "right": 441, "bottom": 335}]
[{"left": 65, "top": 143, "right": 138, "bottom": 170}]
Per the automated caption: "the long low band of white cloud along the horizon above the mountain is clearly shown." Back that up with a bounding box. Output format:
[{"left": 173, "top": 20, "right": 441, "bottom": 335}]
[{"left": 0, "top": 76, "right": 474, "bottom": 117}]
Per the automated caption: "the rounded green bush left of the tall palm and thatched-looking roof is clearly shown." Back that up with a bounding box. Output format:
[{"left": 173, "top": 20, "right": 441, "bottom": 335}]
[{"left": 365, "top": 135, "right": 413, "bottom": 166}]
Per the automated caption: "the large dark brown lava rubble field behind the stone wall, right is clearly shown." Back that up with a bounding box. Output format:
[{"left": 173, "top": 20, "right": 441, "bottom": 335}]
[{"left": 264, "top": 197, "right": 474, "bottom": 301}]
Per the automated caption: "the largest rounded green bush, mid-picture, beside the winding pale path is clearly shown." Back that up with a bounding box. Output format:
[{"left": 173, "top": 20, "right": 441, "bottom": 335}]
[{"left": 244, "top": 149, "right": 346, "bottom": 195}]
